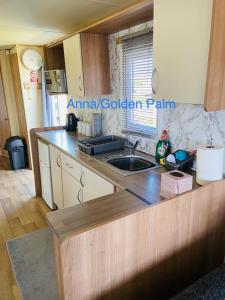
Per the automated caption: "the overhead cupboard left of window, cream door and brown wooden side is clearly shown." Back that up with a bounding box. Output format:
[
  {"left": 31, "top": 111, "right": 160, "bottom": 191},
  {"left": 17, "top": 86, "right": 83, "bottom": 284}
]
[{"left": 63, "top": 33, "right": 110, "bottom": 98}]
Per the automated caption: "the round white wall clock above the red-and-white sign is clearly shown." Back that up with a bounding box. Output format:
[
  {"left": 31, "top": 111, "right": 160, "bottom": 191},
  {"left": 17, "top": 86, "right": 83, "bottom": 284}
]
[{"left": 22, "top": 49, "right": 43, "bottom": 71}]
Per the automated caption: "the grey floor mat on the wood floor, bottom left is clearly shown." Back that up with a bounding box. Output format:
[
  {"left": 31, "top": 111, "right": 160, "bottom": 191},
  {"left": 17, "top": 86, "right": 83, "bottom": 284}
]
[{"left": 7, "top": 228, "right": 59, "bottom": 300}]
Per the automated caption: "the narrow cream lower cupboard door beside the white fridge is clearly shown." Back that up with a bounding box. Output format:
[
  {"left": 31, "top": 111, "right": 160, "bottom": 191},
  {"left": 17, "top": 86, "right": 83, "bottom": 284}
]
[{"left": 49, "top": 145, "right": 64, "bottom": 209}]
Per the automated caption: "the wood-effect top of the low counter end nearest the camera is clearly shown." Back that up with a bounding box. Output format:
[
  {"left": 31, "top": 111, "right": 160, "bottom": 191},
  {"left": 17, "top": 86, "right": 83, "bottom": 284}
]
[{"left": 48, "top": 191, "right": 148, "bottom": 241}]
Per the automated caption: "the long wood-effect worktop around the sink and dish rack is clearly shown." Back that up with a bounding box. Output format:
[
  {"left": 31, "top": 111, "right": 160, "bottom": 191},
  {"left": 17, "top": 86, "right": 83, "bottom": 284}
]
[{"left": 37, "top": 130, "right": 198, "bottom": 204}]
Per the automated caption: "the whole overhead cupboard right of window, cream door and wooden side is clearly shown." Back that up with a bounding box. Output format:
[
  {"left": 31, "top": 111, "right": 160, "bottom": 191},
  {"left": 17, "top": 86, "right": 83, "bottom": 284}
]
[{"left": 152, "top": 0, "right": 225, "bottom": 111}]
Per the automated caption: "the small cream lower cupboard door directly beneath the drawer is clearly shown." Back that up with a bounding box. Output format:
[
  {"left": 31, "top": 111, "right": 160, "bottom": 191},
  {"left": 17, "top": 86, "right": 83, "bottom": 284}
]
[{"left": 62, "top": 169, "right": 82, "bottom": 208}]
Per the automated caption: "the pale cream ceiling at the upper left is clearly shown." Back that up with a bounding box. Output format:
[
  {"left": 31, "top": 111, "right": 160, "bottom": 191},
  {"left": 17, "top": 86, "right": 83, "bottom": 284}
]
[{"left": 0, "top": 0, "right": 141, "bottom": 49}]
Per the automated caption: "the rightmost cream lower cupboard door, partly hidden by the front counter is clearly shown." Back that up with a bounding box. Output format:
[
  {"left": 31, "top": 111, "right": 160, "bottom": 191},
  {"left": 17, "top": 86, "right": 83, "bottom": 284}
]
[{"left": 81, "top": 167, "right": 114, "bottom": 201}]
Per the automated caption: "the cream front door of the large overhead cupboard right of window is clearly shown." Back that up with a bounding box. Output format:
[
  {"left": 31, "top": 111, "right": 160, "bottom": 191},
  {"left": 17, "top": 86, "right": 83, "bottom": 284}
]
[{"left": 153, "top": 0, "right": 213, "bottom": 104}]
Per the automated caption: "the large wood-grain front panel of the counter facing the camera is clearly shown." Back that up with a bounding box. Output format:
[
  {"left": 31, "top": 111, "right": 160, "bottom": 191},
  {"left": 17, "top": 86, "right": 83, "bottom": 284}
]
[{"left": 55, "top": 181, "right": 225, "bottom": 300}]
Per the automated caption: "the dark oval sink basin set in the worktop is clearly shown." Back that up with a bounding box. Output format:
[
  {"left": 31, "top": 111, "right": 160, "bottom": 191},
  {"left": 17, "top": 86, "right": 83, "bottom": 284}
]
[{"left": 107, "top": 156, "right": 156, "bottom": 172}]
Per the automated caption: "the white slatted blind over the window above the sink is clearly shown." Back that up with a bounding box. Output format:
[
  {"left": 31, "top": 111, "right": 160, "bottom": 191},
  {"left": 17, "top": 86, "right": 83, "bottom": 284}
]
[{"left": 121, "top": 31, "right": 157, "bottom": 136}]
